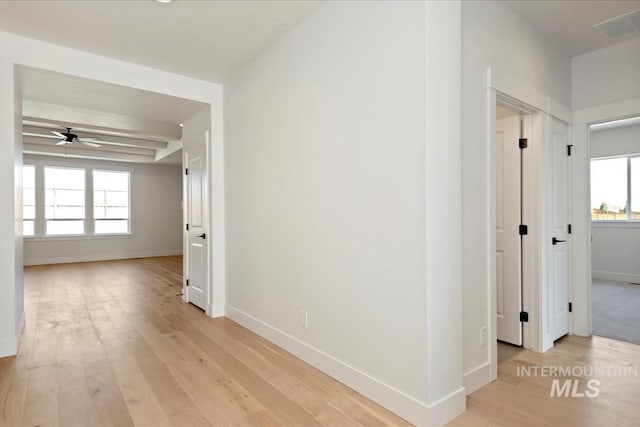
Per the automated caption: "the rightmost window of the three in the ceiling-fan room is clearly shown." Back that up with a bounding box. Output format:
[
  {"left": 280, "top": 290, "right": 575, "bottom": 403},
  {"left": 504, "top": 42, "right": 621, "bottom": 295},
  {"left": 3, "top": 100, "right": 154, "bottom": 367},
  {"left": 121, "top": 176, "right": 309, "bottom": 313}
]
[{"left": 93, "top": 170, "right": 129, "bottom": 234}]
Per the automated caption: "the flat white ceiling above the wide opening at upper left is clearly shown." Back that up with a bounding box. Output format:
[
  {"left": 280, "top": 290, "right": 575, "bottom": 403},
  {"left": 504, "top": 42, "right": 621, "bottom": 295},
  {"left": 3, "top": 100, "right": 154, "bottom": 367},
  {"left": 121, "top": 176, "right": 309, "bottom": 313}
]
[{"left": 0, "top": 0, "right": 322, "bottom": 83}]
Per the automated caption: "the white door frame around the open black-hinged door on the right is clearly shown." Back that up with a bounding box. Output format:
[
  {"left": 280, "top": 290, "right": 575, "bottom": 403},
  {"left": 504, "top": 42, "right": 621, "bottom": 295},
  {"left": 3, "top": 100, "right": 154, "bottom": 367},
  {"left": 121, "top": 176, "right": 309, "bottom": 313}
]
[{"left": 484, "top": 67, "right": 574, "bottom": 381}]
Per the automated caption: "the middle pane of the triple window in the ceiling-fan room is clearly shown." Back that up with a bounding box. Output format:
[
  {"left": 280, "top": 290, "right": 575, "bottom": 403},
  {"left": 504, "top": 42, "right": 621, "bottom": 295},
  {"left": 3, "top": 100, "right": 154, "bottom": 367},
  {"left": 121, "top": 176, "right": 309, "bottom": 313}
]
[{"left": 44, "top": 167, "right": 85, "bottom": 224}]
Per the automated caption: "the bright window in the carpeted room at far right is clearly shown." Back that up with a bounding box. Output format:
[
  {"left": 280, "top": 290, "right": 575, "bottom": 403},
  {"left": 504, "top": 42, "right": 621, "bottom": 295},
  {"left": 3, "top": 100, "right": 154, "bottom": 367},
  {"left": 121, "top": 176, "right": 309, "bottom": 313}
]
[{"left": 591, "top": 156, "right": 640, "bottom": 221}]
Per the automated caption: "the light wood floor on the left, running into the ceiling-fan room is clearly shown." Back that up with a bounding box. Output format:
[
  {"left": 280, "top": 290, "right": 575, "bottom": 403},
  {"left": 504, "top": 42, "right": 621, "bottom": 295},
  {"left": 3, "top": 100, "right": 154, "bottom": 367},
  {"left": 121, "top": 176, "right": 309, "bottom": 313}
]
[{"left": 0, "top": 257, "right": 406, "bottom": 427}]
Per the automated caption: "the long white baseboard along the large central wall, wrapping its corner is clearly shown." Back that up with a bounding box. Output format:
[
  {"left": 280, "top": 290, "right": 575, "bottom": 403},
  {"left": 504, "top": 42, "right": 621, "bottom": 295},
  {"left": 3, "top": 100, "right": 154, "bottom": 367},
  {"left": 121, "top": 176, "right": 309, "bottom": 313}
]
[{"left": 225, "top": 305, "right": 466, "bottom": 426}]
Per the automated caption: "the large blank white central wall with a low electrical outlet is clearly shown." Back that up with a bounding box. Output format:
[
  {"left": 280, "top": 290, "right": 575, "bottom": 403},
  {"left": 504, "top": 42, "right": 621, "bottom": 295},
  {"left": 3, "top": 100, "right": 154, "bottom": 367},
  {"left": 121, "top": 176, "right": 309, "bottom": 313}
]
[{"left": 225, "top": 2, "right": 464, "bottom": 424}]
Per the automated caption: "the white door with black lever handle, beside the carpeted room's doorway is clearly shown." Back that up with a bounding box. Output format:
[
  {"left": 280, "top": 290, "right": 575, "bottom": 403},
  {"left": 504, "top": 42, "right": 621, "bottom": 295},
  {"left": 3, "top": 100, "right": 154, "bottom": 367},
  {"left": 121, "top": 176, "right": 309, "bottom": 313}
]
[{"left": 547, "top": 120, "right": 570, "bottom": 340}]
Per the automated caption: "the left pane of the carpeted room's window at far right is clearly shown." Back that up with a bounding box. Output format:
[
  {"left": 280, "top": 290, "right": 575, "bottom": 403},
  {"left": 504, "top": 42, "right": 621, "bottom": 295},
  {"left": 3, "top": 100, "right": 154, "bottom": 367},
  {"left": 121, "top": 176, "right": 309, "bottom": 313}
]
[{"left": 591, "top": 157, "right": 627, "bottom": 221}]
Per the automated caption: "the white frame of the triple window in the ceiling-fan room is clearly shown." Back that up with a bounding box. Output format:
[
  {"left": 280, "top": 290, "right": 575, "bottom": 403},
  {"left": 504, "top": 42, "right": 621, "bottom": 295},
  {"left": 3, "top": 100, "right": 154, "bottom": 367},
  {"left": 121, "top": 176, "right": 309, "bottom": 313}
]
[{"left": 23, "top": 158, "right": 135, "bottom": 242}]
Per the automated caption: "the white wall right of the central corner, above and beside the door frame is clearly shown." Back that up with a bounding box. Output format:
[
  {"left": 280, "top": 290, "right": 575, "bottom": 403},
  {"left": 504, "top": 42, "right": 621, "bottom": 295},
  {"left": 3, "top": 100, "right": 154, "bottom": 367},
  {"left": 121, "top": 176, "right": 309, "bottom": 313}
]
[{"left": 462, "top": 1, "right": 571, "bottom": 391}]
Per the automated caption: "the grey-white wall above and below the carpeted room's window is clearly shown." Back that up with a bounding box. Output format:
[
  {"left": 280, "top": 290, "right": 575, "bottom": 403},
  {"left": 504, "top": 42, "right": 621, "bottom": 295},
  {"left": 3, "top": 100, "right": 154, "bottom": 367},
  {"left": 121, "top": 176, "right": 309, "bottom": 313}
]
[{"left": 590, "top": 125, "right": 640, "bottom": 282}]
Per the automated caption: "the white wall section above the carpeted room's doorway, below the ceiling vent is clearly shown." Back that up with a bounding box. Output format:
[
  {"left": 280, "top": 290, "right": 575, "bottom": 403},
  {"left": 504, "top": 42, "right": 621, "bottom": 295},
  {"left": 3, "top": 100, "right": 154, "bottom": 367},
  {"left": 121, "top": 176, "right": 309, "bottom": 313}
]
[{"left": 571, "top": 38, "right": 640, "bottom": 110}]
